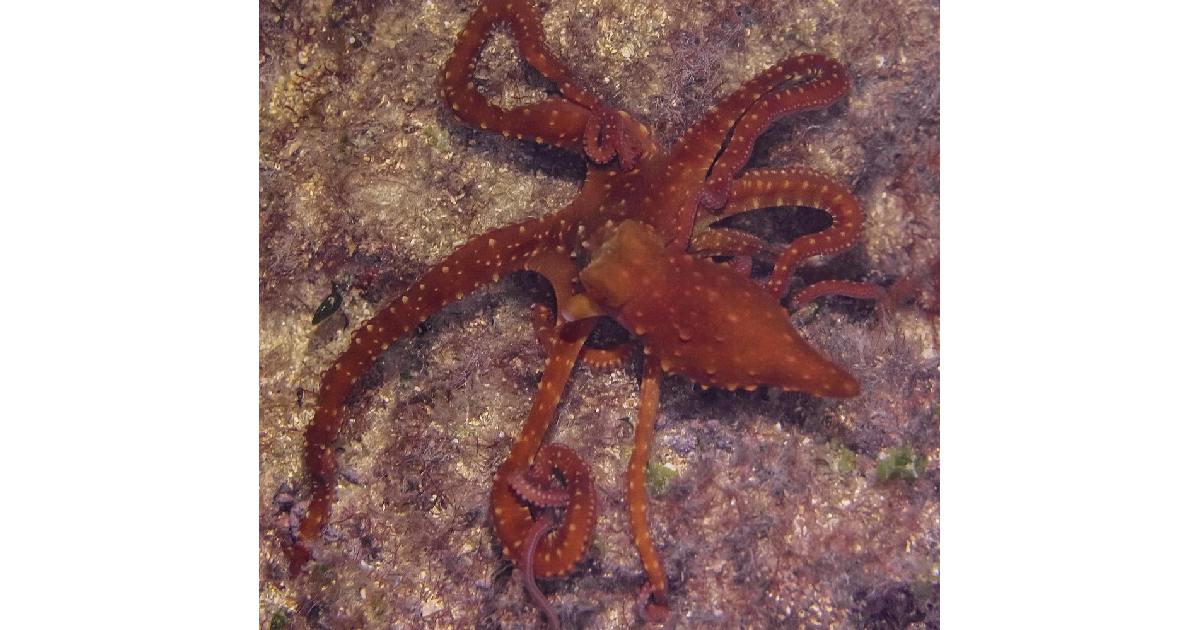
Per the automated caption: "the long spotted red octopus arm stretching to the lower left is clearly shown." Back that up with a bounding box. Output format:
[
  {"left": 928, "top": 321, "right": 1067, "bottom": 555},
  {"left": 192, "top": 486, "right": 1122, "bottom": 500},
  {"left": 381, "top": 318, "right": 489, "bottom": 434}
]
[{"left": 289, "top": 220, "right": 571, "bottom": 575}]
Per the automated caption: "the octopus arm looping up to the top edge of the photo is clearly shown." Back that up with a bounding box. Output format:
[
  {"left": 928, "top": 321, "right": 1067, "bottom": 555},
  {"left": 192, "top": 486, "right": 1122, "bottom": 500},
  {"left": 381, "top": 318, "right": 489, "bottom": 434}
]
[{"left": 442, "top": 0, "right": 649, "bottom": 169}]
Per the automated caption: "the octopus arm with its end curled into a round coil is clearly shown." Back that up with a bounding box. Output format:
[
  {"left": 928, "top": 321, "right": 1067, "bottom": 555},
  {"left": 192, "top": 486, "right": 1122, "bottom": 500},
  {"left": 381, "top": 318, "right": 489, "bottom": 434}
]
[{"left": 491, "top": 319, "right": 595, "bottom": 577}]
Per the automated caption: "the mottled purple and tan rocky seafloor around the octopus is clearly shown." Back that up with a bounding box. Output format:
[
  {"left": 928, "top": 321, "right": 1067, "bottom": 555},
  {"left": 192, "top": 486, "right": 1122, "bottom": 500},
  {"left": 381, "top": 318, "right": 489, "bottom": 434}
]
[{"left": 259, "top": 0, "right": 940, "bottom": 629}]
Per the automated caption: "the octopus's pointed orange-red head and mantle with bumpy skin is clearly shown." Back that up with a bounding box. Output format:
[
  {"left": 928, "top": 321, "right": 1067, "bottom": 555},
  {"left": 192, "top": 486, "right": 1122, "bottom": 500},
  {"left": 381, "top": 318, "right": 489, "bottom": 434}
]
[{"left": 581, "top": 221, "right": 858, "bottom": 397}]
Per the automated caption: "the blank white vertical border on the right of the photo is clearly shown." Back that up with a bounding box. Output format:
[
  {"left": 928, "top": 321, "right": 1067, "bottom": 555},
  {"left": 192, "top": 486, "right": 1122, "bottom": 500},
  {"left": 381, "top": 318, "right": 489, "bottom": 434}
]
[{"left": 941, "top": 0, "right": 1200, "bottom": 629}]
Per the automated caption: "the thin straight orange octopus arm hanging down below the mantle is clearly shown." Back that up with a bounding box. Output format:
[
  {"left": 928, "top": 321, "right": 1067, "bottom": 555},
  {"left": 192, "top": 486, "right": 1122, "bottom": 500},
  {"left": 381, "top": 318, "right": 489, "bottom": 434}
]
[{"left": 625, "top": 356, "right": 670, "bottom": 622}]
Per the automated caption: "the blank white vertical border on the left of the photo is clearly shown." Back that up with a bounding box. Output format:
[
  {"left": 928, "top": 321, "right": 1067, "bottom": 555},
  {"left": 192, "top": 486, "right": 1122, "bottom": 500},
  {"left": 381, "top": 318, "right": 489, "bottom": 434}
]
[{"left": 0, "top": 1, "right": 258, "bottom": 629}]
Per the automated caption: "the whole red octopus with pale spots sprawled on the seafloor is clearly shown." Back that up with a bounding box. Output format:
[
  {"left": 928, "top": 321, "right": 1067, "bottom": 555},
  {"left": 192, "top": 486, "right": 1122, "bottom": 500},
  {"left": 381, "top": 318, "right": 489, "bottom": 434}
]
[{"left": 288, "top": 0, "right": 881, "bottom": 626}]
